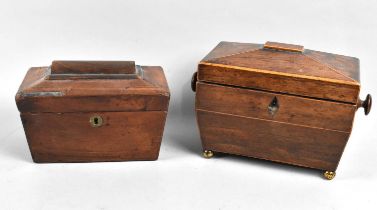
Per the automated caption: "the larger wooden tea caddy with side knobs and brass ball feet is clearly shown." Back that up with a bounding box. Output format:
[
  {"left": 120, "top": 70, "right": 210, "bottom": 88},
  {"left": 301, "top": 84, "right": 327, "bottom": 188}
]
[{"left": 192, "top": 42, "right": 372, "bottom": 179}]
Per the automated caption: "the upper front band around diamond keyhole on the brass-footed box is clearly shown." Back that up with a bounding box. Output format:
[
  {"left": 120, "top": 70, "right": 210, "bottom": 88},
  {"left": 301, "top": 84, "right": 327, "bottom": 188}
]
[{"left": 196, "top": 82, "right": 357, "bottom": 132}]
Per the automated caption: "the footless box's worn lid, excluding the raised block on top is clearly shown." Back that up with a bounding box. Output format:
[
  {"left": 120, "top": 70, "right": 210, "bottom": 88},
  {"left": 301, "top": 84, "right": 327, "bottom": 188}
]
[{"left": 16, "top": 66, "right": 170, "bottom": 112}]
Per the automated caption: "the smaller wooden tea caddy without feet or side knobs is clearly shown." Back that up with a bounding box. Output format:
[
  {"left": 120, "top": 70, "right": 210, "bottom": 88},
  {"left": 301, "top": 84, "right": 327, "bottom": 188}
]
[{"left": 16, "top": 61, "right": 170, "bottom": 163}]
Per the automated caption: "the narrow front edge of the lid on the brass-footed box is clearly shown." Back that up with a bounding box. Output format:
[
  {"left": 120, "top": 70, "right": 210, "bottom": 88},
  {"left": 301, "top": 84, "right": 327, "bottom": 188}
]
[{"left": 198, "top": 63, "right": 360, "bottom": 104}]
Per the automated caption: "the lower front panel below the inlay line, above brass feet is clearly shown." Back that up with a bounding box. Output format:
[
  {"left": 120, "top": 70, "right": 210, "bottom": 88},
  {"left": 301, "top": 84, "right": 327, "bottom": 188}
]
[{"left": 197, "top": 110, "right": 350, "bottom": 171}]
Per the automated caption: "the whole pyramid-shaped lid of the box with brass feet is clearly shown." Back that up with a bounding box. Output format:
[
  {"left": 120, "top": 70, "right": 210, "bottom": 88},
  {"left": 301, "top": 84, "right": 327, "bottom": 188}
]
[{"left": 198, "top": 42, "right": 360, "bottom": 104}]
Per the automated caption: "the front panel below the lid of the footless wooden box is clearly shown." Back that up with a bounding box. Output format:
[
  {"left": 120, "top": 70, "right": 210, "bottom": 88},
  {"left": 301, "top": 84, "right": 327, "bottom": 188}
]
[{"left": 21, "top": 111, "right": 167, "bottom": 163}]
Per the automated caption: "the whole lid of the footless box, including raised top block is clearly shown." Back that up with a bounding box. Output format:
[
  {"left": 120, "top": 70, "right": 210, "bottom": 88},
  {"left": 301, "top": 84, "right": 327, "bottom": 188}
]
[{"left": 16, "top": 61, "right": 170, "bottom": 113}]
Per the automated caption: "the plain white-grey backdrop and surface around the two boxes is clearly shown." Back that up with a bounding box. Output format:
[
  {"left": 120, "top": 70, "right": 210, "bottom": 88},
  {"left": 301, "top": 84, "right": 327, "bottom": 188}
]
[{"left": 0, "top": 0, "right": 377, "bottom": 210}]
